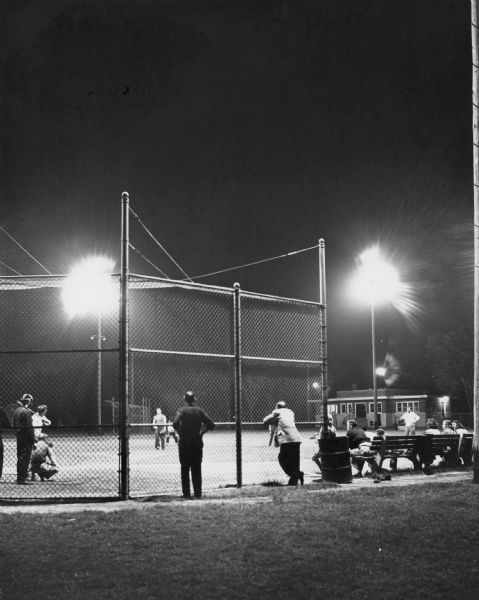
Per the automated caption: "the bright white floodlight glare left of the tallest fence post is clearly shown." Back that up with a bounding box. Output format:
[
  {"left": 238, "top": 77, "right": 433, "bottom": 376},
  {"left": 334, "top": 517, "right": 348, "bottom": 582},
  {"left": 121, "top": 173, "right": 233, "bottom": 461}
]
[{"left": 62, "top": 256, "right": 118, "bottom": 317}]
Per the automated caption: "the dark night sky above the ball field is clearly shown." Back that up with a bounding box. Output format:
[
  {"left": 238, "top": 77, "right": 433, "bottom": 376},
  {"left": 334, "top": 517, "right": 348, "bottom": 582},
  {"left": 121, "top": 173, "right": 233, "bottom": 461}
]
[{"left": 0, "top": 0, "right": 473, "bottom": 386}]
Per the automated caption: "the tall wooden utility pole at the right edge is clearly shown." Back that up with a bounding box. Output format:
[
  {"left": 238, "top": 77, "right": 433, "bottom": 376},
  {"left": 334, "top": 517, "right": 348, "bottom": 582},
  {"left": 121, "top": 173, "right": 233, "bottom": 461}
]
[{"left": 471, "top": 0, "right": 479, "bottom": 483}]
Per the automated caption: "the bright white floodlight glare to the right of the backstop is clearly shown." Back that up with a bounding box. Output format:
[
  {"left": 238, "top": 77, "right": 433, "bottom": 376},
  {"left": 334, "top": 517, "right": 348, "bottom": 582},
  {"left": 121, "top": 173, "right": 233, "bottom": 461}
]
[{"left": 353, "top": 246, "right": 401, "bottom": 304}]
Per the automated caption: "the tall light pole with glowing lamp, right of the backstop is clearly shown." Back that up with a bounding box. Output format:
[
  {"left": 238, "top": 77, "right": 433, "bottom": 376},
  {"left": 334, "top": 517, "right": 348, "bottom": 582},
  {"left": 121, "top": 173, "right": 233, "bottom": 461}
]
[{"left": 355, "top": 246, "right": 399, "bottom": 427}]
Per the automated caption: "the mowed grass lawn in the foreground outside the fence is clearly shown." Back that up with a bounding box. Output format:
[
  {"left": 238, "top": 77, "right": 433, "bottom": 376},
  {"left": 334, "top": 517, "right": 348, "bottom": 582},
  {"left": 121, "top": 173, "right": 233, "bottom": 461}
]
[{"left": 0, "top": 481, "right": 479, "bottom": 600}]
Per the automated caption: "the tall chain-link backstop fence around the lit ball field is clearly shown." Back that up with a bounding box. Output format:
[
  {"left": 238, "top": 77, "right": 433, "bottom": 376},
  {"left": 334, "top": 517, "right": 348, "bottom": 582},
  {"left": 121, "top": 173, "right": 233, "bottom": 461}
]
[{"left": 0, "top": 275, "right": 326, "bottom": 502}]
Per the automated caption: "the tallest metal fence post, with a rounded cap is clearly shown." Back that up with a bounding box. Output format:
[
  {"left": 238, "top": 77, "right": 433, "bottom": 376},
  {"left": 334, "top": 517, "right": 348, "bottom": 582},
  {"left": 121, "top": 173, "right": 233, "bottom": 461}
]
[{"left": 119, "top": 192, "right": 130, "bottom": 500}]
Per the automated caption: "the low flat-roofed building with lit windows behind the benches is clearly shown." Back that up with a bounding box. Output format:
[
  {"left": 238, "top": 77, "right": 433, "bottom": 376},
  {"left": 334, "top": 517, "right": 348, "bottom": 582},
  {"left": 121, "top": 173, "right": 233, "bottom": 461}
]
[{"left": 328, "top": 388, "right": 450, "bottom": 428}]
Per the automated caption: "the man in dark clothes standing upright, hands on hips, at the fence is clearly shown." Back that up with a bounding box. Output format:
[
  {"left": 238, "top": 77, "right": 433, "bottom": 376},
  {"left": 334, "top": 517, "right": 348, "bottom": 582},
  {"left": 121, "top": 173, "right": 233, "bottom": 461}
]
[{"left": 173, "top": 392, "right": 215, "bottom": 500}]
